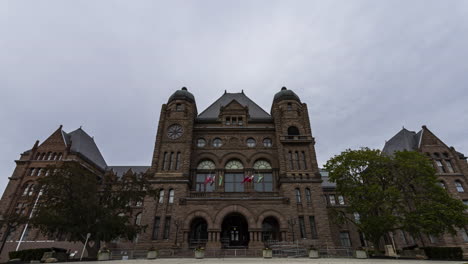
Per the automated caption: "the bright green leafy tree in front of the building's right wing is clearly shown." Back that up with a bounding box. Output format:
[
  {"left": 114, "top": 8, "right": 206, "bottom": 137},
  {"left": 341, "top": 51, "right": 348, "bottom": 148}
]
[{"left": 324, "top": 148, "right": 468, "bottom": 246}]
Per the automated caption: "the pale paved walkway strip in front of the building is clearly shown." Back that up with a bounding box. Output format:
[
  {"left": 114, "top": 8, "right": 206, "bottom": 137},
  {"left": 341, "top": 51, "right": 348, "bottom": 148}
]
[{"left": 81, "top": 258, "right": 468, "bottom": 264}]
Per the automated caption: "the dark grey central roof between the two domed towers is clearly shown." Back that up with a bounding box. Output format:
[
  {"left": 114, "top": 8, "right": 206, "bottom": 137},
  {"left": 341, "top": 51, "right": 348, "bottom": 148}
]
[{"left": 198, "top": 92, "right": 271, "bottom": 120}]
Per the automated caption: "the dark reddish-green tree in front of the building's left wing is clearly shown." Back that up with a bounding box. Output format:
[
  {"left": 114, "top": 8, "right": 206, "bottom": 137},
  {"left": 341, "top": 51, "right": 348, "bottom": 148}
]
[{"left": 32, "top": 162, "right": 153, "bottom": 257}]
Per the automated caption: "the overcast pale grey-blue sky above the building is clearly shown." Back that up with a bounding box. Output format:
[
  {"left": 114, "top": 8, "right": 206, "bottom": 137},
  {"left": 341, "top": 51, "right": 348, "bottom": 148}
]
[{"left": 0, "top": 0, "right": 468, "bottom": 190}]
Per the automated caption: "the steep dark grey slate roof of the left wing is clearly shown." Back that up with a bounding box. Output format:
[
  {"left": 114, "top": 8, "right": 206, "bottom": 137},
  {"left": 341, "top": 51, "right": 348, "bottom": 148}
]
[{"left": 62, "top": 127, "right": 107, "bottom": 169}]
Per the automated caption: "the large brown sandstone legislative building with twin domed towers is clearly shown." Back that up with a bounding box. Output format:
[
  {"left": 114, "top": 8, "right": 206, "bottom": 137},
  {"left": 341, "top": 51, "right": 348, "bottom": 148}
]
[{"left": 0, "top": 87, "right": 468, "bottom": 260}]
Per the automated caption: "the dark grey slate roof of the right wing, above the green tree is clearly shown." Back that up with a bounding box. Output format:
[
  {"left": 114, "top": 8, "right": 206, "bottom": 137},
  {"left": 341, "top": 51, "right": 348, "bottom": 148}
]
[{"left": 382, "top": 128, "right": 422, "bottom": 155}]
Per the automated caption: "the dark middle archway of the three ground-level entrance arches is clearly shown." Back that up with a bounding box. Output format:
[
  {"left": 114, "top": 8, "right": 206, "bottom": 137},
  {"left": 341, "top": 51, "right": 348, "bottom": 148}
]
[{"left": 221, "top": 213, "right": 249, "bottom": 248}]
